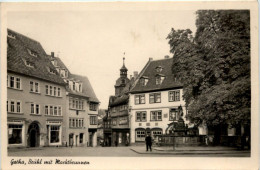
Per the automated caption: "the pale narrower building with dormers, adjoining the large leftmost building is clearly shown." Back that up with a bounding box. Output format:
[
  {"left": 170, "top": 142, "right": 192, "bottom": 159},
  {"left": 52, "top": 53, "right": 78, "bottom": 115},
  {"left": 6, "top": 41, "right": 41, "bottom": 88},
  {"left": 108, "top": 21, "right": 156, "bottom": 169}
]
[{"left": 50, "top": 52, "right": 99, "bottom": 146}]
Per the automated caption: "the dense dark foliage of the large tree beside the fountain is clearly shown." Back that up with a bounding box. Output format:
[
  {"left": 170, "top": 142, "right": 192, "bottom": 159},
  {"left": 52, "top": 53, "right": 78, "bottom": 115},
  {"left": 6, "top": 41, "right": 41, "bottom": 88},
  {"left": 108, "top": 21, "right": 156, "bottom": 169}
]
[{"left": 167, "top": 10, "right": 251, "bottom": 125}]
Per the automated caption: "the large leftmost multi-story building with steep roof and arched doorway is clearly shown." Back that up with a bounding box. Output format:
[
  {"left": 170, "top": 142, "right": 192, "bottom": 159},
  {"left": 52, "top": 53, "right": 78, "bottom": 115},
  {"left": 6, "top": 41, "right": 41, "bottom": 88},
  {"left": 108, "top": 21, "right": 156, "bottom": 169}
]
[{"left": 6, "top": 29, "right": 66, "bottom": 147}]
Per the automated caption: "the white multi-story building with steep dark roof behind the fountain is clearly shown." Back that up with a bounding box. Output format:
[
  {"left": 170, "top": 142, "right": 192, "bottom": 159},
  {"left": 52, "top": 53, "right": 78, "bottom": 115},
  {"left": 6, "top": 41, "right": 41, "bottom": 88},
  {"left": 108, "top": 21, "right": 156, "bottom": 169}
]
[{"left": 129, "top": 57, "right": 188, "bottom": 143}]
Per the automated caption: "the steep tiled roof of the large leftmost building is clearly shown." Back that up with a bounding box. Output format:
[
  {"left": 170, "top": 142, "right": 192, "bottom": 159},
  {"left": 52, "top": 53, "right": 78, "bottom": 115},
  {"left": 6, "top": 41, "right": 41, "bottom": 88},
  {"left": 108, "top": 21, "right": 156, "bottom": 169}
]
[{"left": 7, "top": 29, "right": 65, "bottom": 85}]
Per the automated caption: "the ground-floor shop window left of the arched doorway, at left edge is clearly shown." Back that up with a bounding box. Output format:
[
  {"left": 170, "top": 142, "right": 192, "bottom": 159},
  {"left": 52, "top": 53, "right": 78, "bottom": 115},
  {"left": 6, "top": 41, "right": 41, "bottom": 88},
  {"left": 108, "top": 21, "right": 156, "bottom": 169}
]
[{"left": 8, "top": 124, "right": 23, "bottom": 144}]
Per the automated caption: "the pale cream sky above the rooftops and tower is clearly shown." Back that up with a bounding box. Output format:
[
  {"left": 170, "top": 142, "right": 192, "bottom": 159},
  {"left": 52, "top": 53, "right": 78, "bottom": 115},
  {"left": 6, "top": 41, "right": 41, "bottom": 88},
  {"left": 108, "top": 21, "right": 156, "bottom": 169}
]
[{"left": 7, "top": 5, "right": 196, "bottom": 109}]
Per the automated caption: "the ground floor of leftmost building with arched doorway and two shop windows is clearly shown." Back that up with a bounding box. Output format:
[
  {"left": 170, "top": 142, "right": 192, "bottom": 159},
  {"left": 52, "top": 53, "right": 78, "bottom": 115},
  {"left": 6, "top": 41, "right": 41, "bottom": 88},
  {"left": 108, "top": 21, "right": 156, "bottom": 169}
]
[{"left": 7, "top": 118, "right": 64, "bottom": 147}]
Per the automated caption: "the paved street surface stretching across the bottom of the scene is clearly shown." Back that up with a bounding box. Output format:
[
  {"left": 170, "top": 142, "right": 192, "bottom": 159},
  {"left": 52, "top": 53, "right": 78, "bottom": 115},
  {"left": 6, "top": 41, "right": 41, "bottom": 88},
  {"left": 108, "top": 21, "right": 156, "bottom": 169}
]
[{"left": 8, "top": 146, "right": 250, "bottom": 157}]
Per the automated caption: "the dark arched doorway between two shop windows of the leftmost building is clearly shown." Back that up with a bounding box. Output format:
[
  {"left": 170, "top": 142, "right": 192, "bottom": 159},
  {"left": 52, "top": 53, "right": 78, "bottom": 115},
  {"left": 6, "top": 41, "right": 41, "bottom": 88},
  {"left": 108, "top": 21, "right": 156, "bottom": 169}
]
[{"left": 28, "top": 123, "right": 40, "bottom": 147}]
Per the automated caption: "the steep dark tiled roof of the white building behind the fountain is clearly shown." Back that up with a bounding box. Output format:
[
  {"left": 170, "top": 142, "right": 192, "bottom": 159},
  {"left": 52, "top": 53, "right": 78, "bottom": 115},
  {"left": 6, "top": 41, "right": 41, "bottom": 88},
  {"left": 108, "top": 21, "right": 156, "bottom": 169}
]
[{"left": 130, "top": 58, "right": 182, "bottom": 93}]
